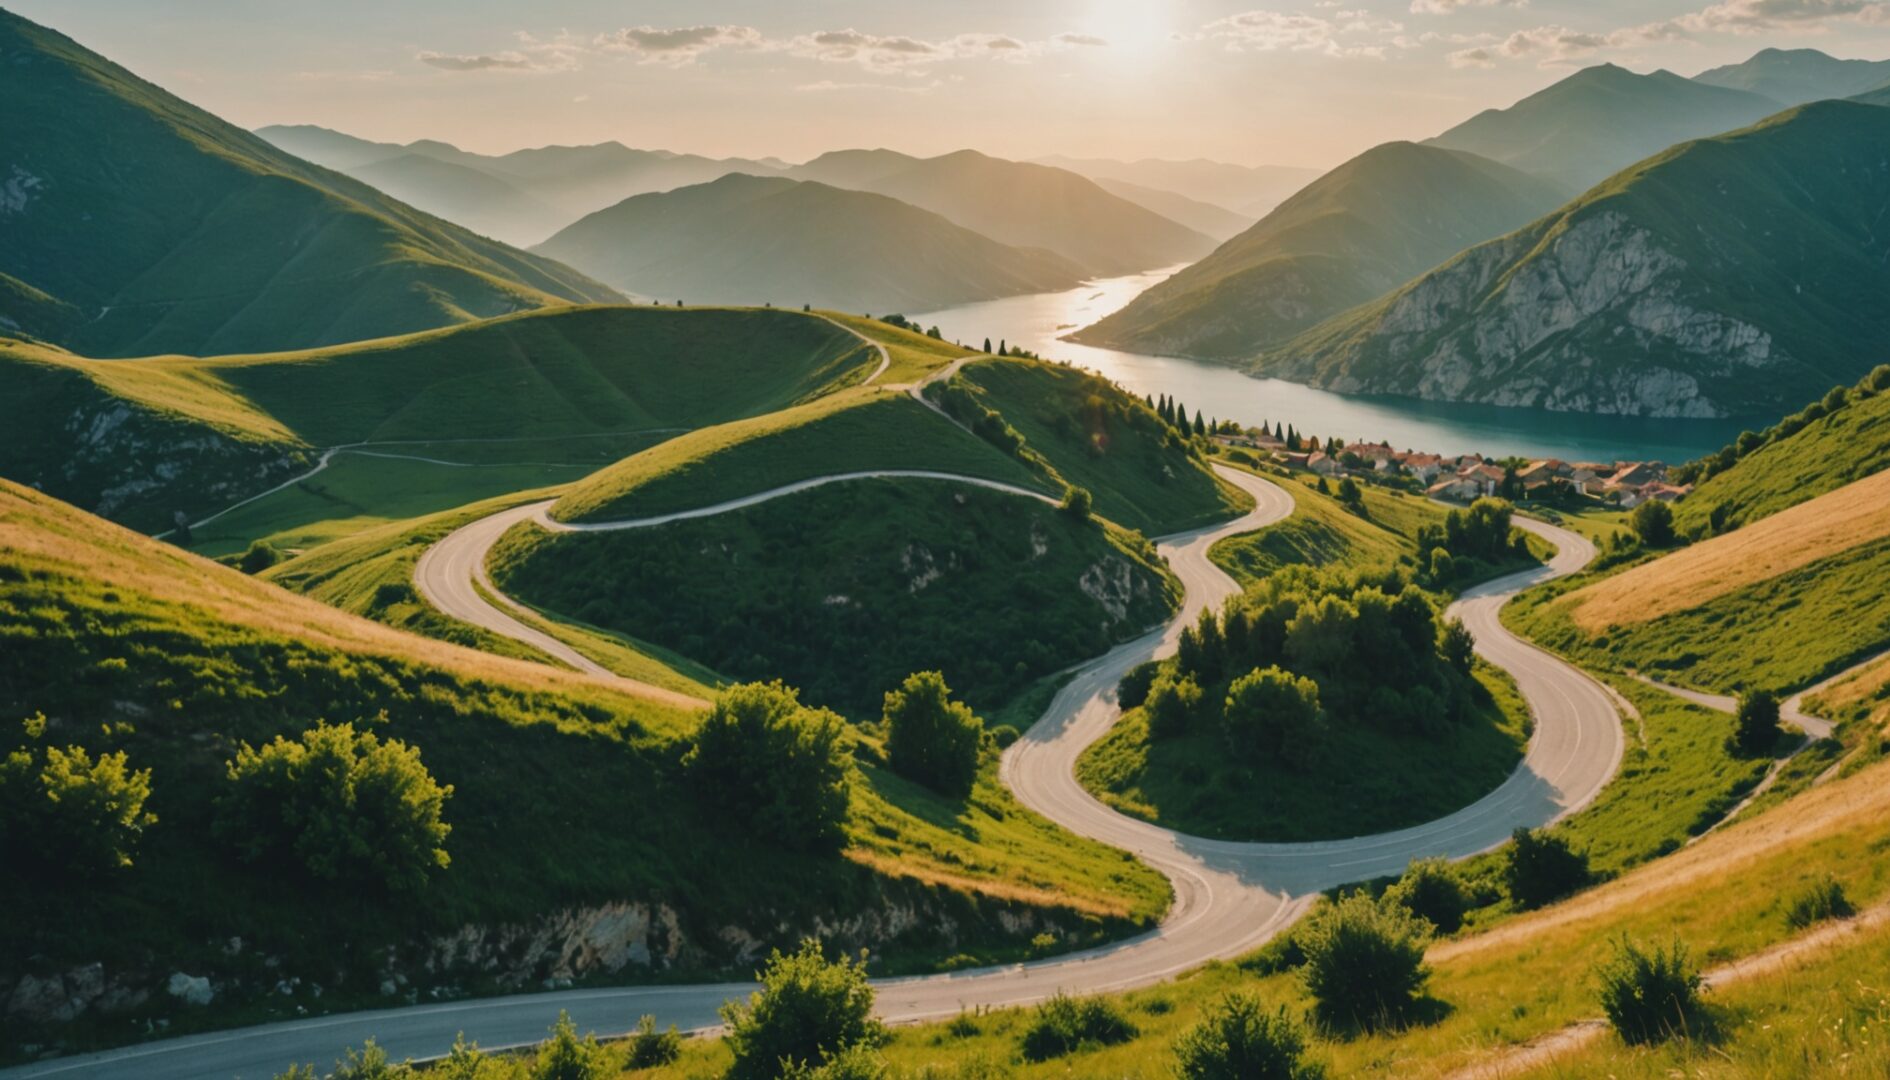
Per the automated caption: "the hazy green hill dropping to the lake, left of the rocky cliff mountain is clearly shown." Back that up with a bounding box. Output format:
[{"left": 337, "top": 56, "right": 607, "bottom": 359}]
[{"left": 1074, "top": 142, "right": 1563, "bottom": 359}]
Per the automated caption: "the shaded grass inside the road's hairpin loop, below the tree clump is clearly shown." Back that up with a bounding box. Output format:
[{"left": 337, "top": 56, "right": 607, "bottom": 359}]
[{"left": 1077, "top": 668, "right": 1529, "bottom": 842}]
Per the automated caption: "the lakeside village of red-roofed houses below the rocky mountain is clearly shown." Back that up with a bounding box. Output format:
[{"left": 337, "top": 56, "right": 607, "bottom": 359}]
[{"left": 1215, "top": 433, "right": 1693, "bottom": 509}]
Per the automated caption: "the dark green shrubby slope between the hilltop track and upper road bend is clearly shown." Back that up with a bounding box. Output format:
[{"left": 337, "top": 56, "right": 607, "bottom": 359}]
[{"left": 934, "top": 357, "right": 1251, "bottom": 535}]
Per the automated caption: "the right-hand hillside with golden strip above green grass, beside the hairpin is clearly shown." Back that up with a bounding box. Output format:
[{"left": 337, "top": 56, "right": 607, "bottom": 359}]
[{"left": 1510, "top": 473, "right": 1890, "bottom": 690}]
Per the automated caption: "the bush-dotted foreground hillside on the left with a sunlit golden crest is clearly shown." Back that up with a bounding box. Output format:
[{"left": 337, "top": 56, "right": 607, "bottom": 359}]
[{"left": 0, "top": 486, "right": 1168, "bottom": 1046}]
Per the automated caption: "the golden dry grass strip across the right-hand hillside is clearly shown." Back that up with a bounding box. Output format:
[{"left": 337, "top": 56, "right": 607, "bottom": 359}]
[{"left": 1563, "top": 471, "right": 1890, "bottom": 634}]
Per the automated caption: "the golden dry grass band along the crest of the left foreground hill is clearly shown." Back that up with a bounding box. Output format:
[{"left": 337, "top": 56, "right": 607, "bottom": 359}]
[{"left": 0, "top": 480, "right": 706, "bottom": 707}]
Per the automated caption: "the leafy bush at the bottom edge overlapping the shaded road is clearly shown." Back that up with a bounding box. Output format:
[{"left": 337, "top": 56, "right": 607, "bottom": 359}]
[{"left": 722, "top": 938, "right": 886, "bottom": 1080}]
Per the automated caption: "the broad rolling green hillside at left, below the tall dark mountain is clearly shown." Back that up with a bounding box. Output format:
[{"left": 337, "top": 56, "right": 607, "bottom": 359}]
[{"left": 0, "top": 308, "right": 879, "bottom": 543}]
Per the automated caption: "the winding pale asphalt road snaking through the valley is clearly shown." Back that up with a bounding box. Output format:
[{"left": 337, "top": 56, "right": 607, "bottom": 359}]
[{"left": 0, "top": 465, "right": 1624, "bottom": 1080}]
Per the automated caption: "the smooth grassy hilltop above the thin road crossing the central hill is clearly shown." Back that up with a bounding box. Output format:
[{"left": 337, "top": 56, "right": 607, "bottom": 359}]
[{"left": 552, "top": 388, "right": 1062, "bottom": 522}]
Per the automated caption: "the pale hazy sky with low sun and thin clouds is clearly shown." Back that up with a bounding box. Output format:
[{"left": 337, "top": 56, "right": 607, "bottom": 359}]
[{"left": 14, "top": 0, "right": 1890, "bottom": 168}]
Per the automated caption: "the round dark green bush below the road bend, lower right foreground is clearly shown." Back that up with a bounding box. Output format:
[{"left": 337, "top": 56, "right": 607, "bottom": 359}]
[{"left": 1295, "top": 893, "right": 1431, "bottom": 1031}]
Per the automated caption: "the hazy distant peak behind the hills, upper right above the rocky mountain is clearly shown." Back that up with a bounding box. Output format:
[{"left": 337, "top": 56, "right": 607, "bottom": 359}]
[{"left": 1429, "top": 64, "right": 1784, "bottom": 191}]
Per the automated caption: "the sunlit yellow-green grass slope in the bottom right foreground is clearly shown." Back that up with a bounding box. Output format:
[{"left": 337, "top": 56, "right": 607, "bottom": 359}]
[{"left": 627, "top": 752, "right": 1890, "bottom": 1080}]
